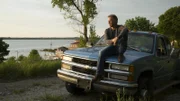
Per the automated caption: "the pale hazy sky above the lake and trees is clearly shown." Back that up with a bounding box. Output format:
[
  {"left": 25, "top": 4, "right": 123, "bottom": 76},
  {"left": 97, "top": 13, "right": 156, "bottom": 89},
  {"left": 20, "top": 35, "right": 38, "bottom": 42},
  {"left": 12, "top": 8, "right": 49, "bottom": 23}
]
[{"left": 0, "top": 0, "right": 180, "bottom": 37}]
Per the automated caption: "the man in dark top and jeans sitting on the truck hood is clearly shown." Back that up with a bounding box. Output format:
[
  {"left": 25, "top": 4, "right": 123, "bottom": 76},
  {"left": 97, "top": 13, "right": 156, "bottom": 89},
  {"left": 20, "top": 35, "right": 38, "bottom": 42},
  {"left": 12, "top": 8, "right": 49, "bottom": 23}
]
[{"left": 93, "top": 14, "right": 128, "bottom": 82}]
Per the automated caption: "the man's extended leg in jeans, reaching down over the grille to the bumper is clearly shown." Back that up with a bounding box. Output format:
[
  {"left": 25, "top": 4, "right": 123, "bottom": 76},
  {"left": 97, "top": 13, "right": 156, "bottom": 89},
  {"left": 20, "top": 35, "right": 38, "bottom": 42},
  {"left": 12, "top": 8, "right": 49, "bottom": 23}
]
[{"left": 94, "top": 45, "right": 117, "bottom": 81}]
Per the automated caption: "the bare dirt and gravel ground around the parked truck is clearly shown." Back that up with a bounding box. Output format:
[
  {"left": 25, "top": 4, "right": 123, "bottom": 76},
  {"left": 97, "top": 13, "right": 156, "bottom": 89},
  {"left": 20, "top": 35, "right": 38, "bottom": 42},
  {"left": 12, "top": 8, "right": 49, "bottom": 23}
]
[{"left": 0, "top": 77, "right": 180, "bottom": 101}]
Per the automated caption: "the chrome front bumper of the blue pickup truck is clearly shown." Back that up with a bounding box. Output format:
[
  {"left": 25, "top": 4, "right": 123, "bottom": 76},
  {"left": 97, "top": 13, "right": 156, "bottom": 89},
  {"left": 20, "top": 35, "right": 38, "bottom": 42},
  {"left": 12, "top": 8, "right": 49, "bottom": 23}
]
[{"left": 57, "top": 69, "right": 138, "bottom": 95}]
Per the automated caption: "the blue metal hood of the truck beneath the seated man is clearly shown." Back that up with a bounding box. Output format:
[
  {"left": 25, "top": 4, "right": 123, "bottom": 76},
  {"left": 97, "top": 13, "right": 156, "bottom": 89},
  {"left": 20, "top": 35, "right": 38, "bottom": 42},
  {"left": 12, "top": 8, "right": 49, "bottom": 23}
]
[{"left": 64, "top": 47, "right": 152, "bottom": 64}]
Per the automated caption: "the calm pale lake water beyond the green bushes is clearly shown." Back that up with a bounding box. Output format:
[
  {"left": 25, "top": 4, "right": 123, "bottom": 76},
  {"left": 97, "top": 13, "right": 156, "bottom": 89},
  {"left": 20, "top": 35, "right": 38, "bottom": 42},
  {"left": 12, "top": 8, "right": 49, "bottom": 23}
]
[{"left": 3, "top": 39, "right": 75, "bottom": 57}]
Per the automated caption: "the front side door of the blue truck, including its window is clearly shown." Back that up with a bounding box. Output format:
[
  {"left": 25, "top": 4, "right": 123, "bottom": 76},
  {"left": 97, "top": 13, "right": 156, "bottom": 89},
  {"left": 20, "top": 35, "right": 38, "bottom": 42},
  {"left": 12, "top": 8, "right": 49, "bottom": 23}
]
[{"left": 155, "top": 36, "right": 174, "bottom": 86}]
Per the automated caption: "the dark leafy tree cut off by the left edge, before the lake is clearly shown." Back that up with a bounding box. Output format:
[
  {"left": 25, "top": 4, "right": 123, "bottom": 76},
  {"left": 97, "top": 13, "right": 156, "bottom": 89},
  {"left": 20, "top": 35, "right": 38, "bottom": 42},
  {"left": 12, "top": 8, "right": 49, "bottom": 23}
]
[{"left": 0, "top": 39, "right": 9, "bottom": 63}]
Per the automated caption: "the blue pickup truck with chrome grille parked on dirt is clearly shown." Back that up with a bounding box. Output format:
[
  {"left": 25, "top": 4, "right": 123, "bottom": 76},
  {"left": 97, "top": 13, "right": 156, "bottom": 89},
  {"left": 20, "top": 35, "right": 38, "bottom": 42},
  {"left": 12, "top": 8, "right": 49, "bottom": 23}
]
[{"left": 57, "top": 31, "right": 180, "bottom": 97}]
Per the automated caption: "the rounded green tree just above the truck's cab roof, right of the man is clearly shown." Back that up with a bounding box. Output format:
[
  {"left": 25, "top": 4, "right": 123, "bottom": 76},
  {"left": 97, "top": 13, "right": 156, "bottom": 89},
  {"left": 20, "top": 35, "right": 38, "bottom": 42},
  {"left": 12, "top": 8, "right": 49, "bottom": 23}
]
[{"left": 125, "top": 16, "right": 157, "bottom": 31}]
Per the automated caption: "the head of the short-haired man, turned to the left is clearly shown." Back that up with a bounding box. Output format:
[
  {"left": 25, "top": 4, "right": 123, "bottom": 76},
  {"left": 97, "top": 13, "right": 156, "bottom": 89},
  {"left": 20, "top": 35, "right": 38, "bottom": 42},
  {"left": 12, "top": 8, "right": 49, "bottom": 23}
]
[{"left": 108, "top": 14, "right": 118, "bottom": 27}]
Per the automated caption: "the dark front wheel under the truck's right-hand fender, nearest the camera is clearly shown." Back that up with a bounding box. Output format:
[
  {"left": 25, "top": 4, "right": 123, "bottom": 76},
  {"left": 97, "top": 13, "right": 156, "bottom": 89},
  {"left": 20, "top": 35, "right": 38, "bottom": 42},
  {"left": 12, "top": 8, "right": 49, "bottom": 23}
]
[{"left": 134, "top": 77, "right": 154, "bottom": 101}]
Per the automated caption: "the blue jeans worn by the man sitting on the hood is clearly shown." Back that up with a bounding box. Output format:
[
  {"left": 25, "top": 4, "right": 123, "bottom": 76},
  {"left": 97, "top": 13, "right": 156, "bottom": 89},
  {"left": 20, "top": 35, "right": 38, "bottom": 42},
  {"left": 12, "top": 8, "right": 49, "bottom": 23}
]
[{"left": 96, "top": 45, "right": 127, "bottom": 75}]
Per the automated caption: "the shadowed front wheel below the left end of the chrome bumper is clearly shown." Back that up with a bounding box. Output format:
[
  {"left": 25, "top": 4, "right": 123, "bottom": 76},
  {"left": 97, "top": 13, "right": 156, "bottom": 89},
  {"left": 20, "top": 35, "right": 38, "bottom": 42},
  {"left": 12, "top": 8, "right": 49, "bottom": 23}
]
[{"left": 65, "top": 82, "right": 85, "bottom": 95}]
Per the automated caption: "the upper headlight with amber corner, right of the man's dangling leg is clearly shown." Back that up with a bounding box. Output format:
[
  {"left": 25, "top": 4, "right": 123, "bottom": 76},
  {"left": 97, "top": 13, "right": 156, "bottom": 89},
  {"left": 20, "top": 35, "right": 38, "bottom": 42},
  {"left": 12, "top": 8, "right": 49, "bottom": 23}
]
[{"left": 111, "top": 64, "right": 134, "bottom": 72}]
